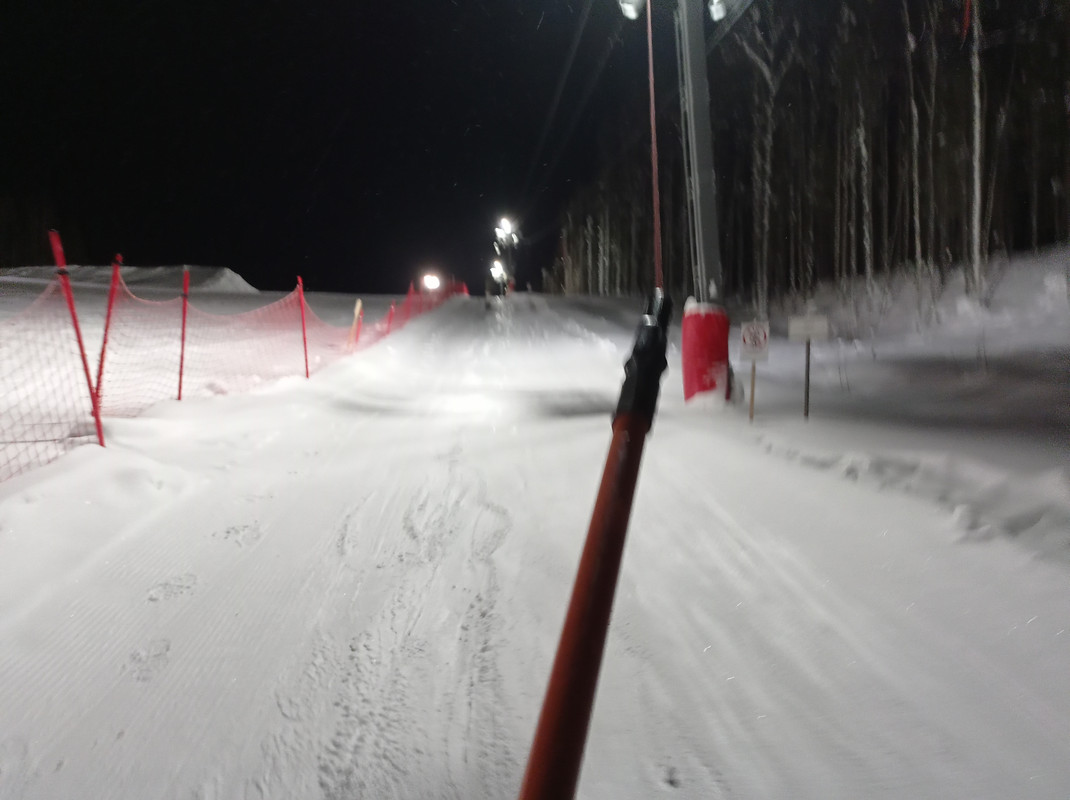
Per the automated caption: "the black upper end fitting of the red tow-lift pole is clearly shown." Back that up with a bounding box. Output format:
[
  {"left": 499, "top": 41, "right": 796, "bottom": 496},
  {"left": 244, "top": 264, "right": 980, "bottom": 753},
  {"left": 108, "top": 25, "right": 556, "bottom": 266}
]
[{"left": 613, "top": 289, "right": 672, "bottom": 430}]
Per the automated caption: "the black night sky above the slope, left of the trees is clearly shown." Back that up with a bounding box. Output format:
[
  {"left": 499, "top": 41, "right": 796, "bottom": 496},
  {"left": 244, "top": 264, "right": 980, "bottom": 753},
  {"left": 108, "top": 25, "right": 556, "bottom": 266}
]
[{"left": 0, "top": 0, "right": 674, "bottom": 291}]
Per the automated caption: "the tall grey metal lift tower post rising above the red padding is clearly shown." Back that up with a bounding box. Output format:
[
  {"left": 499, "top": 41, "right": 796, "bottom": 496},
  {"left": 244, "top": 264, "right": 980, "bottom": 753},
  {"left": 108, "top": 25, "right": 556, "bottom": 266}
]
[{"left": 678, "top": 0, "right": 722, "bottom": 303}]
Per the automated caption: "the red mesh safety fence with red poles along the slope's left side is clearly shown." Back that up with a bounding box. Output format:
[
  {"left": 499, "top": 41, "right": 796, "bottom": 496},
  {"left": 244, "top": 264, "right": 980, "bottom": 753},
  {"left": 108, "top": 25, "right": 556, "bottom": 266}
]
[{"left": 0, "top": 243, "right": 467, "bottom": 480}]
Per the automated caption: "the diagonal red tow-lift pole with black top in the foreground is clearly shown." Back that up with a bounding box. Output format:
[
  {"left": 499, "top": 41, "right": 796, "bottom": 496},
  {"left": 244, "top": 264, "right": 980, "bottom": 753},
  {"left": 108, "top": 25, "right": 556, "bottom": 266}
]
[{"left": 520, "top": 289, "right": 672, "bottom": 800}]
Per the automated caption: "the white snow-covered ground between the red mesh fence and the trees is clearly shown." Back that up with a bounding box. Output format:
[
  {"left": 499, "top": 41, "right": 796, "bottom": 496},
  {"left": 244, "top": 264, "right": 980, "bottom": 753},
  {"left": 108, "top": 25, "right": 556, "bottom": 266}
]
[{"left": 0, "top": 251, "right": 1070, "bottom": 800}]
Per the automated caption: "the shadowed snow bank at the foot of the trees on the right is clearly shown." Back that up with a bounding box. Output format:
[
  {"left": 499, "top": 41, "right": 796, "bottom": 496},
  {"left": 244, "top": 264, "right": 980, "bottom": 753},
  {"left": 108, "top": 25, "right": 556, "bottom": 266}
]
[{"left": 701, "top": 247, "right": 1070, "bottom": 563}]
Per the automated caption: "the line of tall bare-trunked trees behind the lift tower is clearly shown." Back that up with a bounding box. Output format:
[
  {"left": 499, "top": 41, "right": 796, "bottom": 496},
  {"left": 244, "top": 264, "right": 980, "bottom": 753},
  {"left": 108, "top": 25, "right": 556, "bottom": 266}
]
[{"left": 545, "top": 0, "right": 1070, "bottom": 317}]
